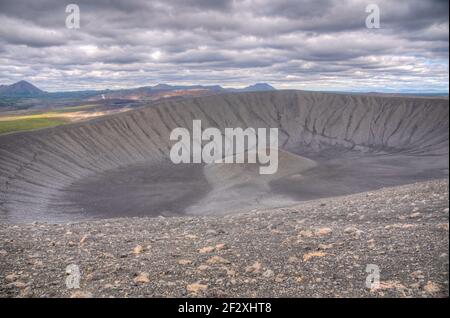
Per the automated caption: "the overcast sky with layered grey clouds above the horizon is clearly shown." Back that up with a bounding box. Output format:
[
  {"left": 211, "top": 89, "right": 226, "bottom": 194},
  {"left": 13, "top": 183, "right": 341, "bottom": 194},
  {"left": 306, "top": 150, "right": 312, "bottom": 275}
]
[{"left": 0, "top": 0, "right": 449, "bottom": 92}]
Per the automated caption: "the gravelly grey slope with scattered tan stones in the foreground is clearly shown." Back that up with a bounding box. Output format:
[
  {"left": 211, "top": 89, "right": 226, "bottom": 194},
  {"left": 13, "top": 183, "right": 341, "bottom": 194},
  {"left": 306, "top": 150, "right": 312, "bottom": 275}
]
[{"left": 0, "top": 180, "right": 449, "bottom": 297}]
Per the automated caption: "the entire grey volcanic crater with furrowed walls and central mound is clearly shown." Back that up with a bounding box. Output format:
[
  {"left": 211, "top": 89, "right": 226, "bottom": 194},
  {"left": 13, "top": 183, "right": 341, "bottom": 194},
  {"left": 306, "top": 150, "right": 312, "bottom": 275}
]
[{"left": 0, "top": 91, "right": 449, "bottom": 223}]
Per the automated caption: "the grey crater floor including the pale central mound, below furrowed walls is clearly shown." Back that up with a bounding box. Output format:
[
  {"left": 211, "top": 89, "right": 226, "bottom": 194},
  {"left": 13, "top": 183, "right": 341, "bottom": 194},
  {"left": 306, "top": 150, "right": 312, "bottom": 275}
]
[{"left": 44, "top": 149, "right": 448, "bottom": 221}]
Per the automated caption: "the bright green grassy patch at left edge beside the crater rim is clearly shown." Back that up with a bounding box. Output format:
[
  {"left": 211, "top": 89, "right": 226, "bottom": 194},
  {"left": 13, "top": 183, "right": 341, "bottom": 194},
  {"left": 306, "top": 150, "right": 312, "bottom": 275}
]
[{"left": 0, "top": 117, "right": 67, "bottom": 134}]
